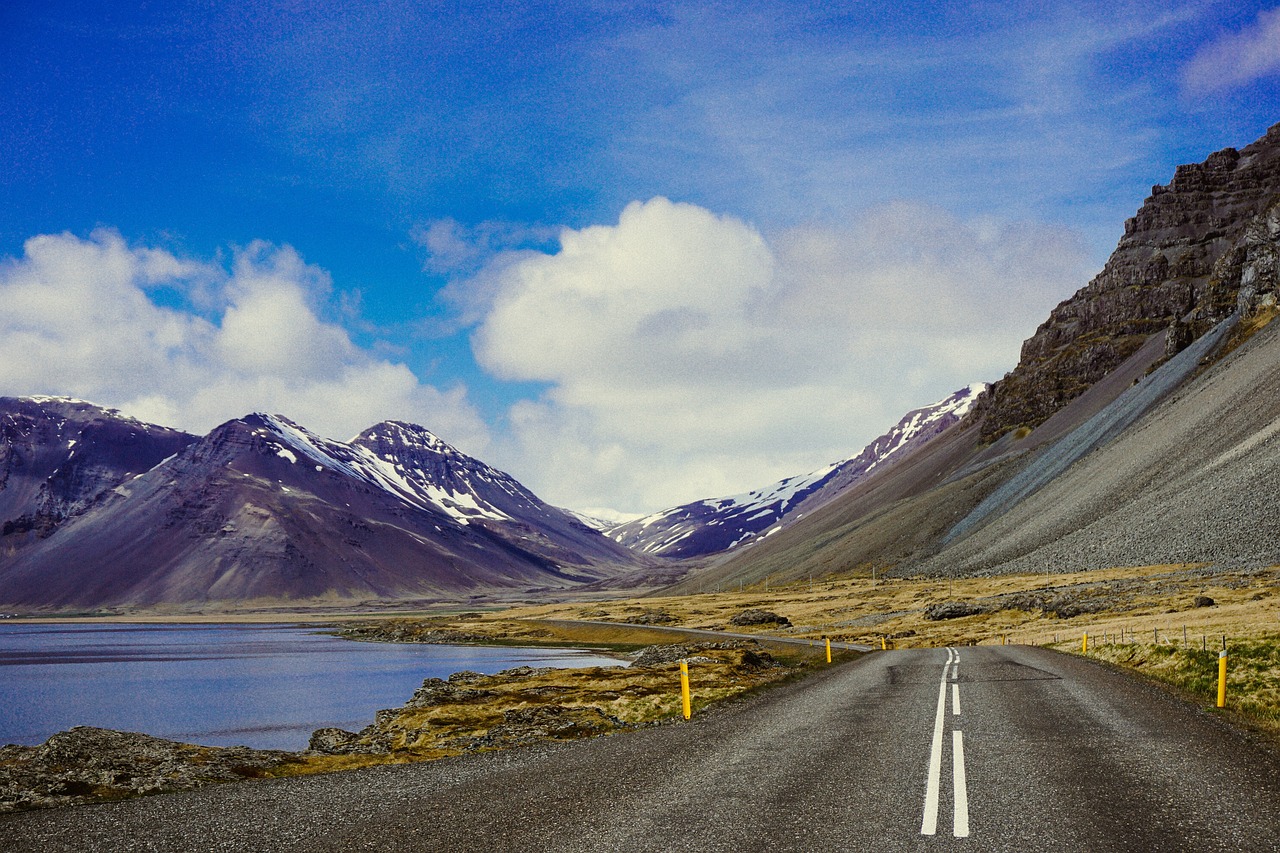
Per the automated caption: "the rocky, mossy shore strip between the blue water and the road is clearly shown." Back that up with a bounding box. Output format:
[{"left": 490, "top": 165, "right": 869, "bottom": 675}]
[{"left": 0, "top": 640, "right": 794, "bottom": 812}]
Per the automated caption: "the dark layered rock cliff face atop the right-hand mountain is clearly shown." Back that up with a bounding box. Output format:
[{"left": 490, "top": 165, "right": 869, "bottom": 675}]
[{"left": 978, "top": 124, "right": 1280, "bottom": 441}]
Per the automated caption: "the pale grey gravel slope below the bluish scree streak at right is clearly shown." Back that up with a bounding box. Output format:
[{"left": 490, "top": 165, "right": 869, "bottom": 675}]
[{"left": 919, "top": 315, "right": 1280, "bottom": 574}]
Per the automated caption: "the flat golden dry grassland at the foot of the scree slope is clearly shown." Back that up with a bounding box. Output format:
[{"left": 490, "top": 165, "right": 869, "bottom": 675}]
[{"left": 473, "top": 565, "right": 1280, "bottom": 648}]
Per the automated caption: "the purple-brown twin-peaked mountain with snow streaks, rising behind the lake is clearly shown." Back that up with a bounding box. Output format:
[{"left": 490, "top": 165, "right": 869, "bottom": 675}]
[{"left": 0, "top": 404, "right": 636, "bottom": 608}]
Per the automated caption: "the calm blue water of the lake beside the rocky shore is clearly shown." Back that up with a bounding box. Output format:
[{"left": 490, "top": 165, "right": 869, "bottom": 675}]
[{"left": 0, "top": 624, "right": 618, "bottom": 749}]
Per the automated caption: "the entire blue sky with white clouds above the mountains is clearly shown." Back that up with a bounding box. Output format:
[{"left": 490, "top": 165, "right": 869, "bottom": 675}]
[{"left": 0, "top": 0, "right": 1280, "bottom": 512}]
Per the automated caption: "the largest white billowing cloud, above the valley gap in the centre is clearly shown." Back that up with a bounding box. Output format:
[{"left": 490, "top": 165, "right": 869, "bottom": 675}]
[{"left": 472, "top": 197, "right": 1088, "bottom": 510}]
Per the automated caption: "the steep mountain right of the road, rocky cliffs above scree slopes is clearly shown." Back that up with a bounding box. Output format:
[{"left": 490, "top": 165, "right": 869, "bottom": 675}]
[{"left": 686, "top": 119, "right": 1280, "bottom": 593}]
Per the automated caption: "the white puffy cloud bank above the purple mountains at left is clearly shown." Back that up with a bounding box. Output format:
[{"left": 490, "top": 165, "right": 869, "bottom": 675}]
[{"left": 0, "top": 231, "right": 488, "bottom": 452}]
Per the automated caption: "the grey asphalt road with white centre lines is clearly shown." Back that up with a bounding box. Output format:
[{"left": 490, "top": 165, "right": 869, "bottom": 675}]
[{"left": 0, "top": 647, "right": 1280, "bottom": 853}]
